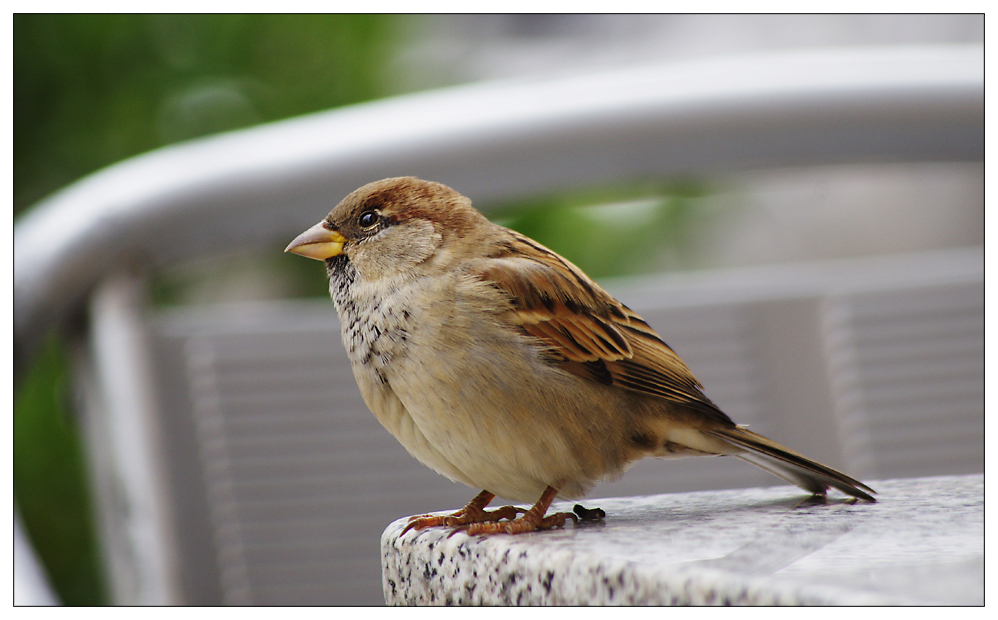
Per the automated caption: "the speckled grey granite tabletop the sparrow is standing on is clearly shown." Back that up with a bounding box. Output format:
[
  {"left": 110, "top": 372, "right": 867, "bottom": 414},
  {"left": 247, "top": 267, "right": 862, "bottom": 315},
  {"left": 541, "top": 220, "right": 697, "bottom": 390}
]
[{"left": 381, "top": 475, "right": 984, "bottom": 605}]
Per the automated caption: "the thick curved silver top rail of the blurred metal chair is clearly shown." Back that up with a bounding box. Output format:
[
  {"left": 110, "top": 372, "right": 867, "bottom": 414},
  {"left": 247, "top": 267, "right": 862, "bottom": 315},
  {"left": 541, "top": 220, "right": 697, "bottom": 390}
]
[{"left": 14, "top": 45, "right": 984, "bottom": 369}]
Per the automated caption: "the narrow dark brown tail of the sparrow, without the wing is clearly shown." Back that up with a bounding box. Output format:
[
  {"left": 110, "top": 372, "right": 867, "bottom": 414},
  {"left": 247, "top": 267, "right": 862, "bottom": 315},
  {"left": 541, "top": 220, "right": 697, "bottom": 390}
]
[{"left": 704, "top": 426, "right": 876, "bottom": 502}]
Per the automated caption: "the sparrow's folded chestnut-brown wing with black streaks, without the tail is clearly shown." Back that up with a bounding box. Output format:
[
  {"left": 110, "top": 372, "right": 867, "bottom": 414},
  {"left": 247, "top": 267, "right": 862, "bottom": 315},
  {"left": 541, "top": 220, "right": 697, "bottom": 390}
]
[{"left": 476, "top": 231, "right": 734, "bottom": 426}]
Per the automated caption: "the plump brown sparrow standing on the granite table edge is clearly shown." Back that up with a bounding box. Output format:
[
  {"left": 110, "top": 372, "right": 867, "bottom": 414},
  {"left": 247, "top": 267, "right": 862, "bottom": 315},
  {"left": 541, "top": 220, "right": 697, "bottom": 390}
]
[{"left": 286, "top": 177, "right": 874, "bottom": 534}]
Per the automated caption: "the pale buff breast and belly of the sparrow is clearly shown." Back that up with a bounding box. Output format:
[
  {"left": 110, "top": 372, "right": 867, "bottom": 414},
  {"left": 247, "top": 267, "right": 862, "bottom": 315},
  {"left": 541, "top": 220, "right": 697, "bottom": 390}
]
[{"left": 330, "top": 264, "right": 636, "bottom": 501}]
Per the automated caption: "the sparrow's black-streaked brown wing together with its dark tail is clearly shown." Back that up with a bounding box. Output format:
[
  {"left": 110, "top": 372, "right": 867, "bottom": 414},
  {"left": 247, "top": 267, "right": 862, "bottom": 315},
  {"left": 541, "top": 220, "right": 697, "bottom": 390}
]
[{"left": 476, "top": 233, "right": 875, "bottom": 501}]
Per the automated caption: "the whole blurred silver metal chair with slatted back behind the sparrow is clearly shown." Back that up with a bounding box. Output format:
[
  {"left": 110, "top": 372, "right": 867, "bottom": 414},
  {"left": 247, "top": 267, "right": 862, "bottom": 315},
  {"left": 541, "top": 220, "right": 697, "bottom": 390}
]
[{"left": 14, "top": 46, "right": 983, "bottom": 604}]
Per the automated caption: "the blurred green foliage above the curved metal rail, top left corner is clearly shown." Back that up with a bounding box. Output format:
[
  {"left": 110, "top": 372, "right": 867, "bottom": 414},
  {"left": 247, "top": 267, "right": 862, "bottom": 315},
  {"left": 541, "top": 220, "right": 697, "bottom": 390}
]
[{"left": 14, "top": 15, "right": 394, "bottom": 213}]
